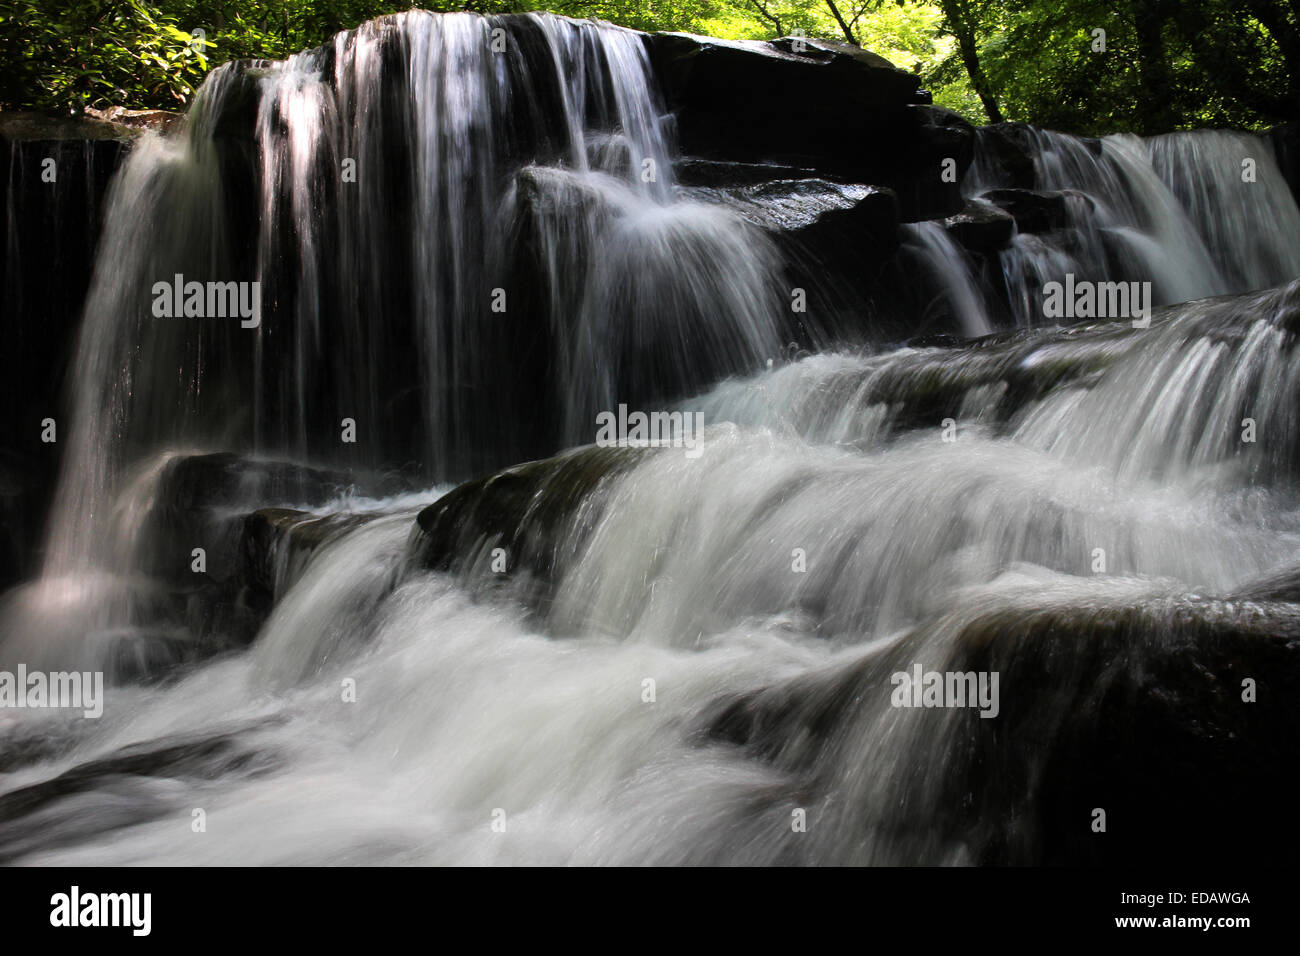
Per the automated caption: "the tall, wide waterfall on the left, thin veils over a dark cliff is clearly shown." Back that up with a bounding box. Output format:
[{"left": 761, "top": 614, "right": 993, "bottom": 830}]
[{"left": 14, "top": 12, "right": 781, "bottom": 665}]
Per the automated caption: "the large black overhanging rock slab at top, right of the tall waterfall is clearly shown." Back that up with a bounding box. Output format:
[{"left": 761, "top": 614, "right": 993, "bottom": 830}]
[{"left": 646, "top": 34, "right": 974, "bottom": 221}]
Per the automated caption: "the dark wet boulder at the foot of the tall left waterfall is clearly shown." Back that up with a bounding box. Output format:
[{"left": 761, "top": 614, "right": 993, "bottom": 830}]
[{"left": 5, "top": 454, "right": 382, "bottom": 683}]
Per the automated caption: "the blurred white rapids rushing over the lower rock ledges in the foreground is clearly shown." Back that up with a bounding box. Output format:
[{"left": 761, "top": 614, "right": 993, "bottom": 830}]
[{"left": 0, "top": 278, "right": 1300, "bottom": 865}]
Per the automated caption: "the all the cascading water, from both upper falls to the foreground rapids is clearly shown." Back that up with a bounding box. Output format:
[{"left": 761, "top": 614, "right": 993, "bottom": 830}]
[{"left": 0, "top": 13, "right": 1300, "bottom": 865}]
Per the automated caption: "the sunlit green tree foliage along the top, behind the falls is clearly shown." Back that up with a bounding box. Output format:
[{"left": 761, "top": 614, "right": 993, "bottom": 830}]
[{"left": 0, "top": 0, "right": 1300, "bottom": 134}]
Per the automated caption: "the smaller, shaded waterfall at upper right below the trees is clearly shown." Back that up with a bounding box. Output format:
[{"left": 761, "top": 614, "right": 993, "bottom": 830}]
[{"left": 963, "top": 129, "right": 1300, "bottom": 325}]
